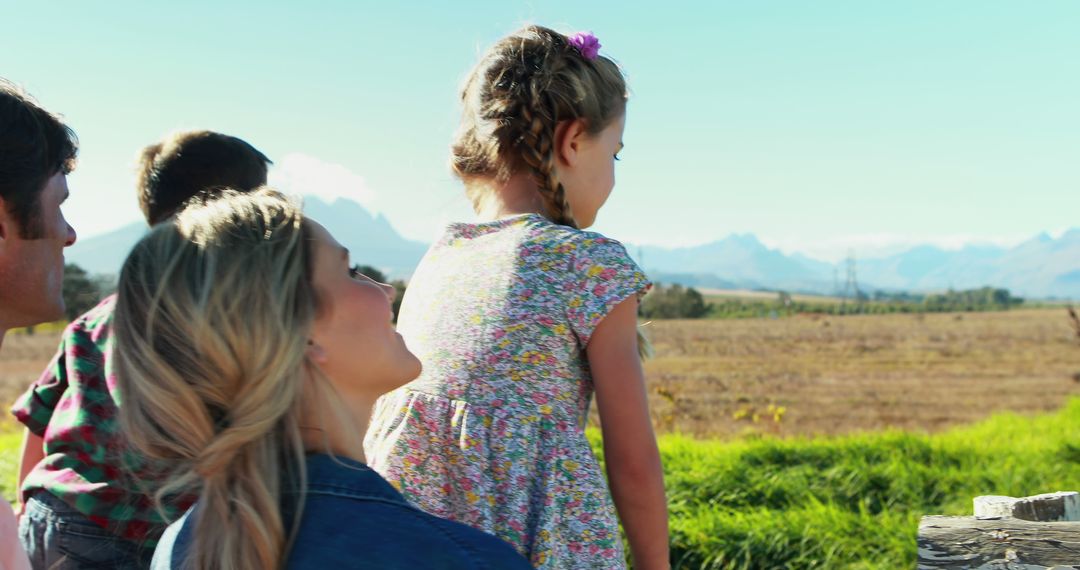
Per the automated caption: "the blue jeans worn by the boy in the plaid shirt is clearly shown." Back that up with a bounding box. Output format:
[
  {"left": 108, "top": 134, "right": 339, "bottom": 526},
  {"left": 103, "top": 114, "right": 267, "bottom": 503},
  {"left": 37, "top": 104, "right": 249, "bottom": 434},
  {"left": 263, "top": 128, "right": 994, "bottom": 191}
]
[{"left": 18, "top": 492, "right": 153, "bottom": 570}]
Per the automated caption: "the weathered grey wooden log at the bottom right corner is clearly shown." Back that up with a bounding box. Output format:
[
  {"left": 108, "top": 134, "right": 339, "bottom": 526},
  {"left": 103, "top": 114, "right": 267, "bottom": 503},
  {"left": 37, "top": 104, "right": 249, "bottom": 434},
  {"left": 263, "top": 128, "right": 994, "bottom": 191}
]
[{"left": 918, "top": 516, "right": 1080, "bottom": 570}]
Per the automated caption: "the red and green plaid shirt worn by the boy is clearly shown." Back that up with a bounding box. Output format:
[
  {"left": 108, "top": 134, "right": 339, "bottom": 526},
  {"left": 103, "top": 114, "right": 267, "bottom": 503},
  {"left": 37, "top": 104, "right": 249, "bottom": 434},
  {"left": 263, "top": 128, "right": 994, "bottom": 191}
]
[{"left": 12, "top": 296, "right": 194, "bottom": 546}]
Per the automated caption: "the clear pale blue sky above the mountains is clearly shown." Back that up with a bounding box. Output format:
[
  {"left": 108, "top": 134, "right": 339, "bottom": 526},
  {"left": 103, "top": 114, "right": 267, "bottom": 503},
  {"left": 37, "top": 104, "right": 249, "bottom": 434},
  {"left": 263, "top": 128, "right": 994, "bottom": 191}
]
[{"left": 0, "top": 0, "right": 1080, "bottom": 259}]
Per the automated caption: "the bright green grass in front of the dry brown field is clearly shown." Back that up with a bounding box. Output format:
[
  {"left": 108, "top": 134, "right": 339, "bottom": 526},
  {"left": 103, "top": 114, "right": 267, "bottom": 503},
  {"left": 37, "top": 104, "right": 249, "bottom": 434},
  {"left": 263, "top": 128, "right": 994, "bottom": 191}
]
[{"left": 8, "top": 398, "right": 1080, "bottom": 570}]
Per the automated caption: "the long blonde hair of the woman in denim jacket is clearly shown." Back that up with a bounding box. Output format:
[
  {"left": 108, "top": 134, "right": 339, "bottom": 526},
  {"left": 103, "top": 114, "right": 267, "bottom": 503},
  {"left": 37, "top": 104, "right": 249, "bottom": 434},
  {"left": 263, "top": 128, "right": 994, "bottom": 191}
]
[{"left": 113, "top": 189, "right": 325, "bottom": 570}]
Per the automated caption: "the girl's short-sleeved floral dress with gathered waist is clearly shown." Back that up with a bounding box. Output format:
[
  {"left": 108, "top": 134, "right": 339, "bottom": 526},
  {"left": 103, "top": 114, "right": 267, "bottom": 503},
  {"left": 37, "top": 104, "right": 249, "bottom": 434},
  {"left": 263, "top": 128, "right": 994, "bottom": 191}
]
[{"left": 364, "top": 214, "right": 650, "bottom": 569}]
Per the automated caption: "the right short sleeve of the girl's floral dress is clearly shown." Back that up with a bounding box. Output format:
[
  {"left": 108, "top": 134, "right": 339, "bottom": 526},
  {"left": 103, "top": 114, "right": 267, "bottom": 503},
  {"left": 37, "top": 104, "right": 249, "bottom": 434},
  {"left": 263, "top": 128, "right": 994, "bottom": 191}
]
[{"left": 566, "top": 238, "right": 652, "bottom": 347}]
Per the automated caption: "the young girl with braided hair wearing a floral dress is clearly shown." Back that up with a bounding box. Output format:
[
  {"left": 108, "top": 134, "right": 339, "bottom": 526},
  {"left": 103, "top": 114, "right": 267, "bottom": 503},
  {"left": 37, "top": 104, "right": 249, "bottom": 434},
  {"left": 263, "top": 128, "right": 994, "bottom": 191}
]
[{"left": 365, "top": 26, "right": 669, "bottom": 569}]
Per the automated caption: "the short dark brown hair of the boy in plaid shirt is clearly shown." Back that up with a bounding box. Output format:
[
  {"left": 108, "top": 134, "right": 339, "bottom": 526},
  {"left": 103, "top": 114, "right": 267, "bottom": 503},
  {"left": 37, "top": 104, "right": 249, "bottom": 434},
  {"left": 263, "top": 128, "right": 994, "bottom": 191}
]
[{"left": 136, "top": 131, "right": 271, "bottom": 226}]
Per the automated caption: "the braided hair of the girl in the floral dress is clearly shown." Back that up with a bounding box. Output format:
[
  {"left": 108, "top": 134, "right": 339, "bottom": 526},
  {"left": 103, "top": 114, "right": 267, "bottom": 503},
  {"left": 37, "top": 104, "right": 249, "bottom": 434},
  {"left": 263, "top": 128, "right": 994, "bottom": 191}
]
[{"left": 450, "top": 26, "right": 626, "bottom": 228}]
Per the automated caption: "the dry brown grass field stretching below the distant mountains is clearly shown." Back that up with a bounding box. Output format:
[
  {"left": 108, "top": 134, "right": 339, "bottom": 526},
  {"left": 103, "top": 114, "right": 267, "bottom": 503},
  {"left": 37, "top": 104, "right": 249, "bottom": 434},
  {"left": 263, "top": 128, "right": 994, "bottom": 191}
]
[{"left": 6, "top": 309, "right": 1080, "bottom": 438}]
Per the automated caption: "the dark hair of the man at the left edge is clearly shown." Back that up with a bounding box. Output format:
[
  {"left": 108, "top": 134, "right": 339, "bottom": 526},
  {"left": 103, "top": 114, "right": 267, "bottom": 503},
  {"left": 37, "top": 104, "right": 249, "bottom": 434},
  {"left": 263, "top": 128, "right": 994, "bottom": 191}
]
[{"left": 0, "top": 79, "right": 79, "bottom": 240}]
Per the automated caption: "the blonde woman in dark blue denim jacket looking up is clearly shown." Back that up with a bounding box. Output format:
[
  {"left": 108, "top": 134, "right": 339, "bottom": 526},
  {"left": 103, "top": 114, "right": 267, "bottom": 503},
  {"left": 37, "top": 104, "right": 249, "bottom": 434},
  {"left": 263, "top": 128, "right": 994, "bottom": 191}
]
[{"left": 114, "top": 190, "right": 528, "bottom": 570}]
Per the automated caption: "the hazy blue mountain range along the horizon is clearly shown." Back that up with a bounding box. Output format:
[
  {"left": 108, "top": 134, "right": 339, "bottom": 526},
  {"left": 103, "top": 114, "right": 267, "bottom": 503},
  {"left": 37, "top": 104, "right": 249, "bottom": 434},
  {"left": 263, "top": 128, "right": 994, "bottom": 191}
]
[{"left": 67, "top": 196, "right": 1080, "bottom": 299}]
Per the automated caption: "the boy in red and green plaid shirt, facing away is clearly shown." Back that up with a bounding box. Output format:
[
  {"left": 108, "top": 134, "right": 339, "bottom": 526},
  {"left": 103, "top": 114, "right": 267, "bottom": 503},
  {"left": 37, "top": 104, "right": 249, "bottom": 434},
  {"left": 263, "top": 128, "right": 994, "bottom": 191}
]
[{"left": 12, "top": 131, "right": 270, "bottom": 568}]
